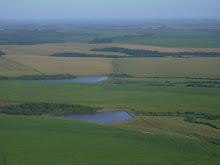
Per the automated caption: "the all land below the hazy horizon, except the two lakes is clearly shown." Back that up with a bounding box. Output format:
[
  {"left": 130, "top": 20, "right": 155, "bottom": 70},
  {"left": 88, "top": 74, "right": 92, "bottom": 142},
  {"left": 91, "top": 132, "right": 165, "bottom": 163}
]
[{"left": 0, "top": 21, "right": 220, "bottom": 165}]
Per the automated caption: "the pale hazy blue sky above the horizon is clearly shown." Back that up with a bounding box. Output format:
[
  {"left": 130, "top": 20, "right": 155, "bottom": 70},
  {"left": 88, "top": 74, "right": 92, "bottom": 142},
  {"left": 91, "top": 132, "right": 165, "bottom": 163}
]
[{"left": 0, "top": 0, "right": 220, "bottom": 20}]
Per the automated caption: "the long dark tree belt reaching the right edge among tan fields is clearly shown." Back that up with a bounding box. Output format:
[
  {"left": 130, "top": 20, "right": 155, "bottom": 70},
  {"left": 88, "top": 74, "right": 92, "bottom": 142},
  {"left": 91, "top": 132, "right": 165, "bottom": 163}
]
[{"left": 91, "top": 47, "right": 220, "bottom": 57}]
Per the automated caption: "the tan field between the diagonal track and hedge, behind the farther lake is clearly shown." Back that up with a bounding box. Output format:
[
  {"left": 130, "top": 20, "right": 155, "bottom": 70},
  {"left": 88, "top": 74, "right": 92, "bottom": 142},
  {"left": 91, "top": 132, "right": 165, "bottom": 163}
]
[{"left": 6, "top": 55, "right": 113, "bottom": 76}]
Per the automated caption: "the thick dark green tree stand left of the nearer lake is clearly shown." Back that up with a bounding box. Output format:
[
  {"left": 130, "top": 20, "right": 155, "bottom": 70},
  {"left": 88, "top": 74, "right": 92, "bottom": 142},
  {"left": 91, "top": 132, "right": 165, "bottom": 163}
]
[{"left": 0, "top": 103, "right": 101, "bottom": 116}]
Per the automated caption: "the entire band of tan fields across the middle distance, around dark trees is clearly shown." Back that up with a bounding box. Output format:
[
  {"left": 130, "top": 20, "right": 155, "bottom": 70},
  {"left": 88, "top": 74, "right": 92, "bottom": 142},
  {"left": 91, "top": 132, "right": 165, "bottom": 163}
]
[{"left": 0, "top": 43, "right": 220, "bottom": 78}]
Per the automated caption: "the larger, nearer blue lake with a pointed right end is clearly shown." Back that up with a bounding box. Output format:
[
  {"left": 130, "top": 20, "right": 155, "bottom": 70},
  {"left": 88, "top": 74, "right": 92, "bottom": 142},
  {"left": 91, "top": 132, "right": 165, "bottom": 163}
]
[{"left": 56, "top": 111, "right": 133, "bottom": 124}]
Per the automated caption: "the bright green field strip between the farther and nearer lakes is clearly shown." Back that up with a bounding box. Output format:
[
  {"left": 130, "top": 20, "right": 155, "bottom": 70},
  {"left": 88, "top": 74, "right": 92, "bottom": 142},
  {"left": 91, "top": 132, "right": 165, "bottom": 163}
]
[{"left": 0, "top": 81, "right": 220, "bottom": 114}]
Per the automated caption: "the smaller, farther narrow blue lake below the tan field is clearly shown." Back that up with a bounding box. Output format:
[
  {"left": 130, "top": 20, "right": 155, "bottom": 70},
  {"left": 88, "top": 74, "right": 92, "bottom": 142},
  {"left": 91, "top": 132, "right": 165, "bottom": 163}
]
[{"left": 34, "top": 77, "right": 108, "bottom": 83}]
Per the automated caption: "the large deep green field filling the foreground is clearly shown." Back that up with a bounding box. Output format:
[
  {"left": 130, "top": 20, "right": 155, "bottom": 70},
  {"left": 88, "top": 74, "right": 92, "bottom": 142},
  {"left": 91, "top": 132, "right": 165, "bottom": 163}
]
[{"left": 0, "top": 115, "right": 220, "bottom": 165}]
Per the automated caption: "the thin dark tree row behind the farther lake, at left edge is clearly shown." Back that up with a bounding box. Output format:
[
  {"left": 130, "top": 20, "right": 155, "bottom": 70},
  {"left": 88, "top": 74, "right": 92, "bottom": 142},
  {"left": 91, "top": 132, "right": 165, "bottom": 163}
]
[{"left": 0, "top": 74, "right": 77, "bottom": 80}]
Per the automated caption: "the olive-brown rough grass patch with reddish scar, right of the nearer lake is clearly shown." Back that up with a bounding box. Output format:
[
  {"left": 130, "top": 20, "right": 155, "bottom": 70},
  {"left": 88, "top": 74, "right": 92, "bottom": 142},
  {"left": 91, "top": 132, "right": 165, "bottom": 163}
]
[{"left": 112, "top": 116, "right": 220, "bottom": 142}]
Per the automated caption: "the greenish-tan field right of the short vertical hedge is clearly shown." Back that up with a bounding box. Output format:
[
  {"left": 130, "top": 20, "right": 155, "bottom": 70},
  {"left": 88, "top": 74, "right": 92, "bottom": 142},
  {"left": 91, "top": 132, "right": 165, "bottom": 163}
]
[{"left": 114, "top": 57, "right": 220, "bottom": 78}]
